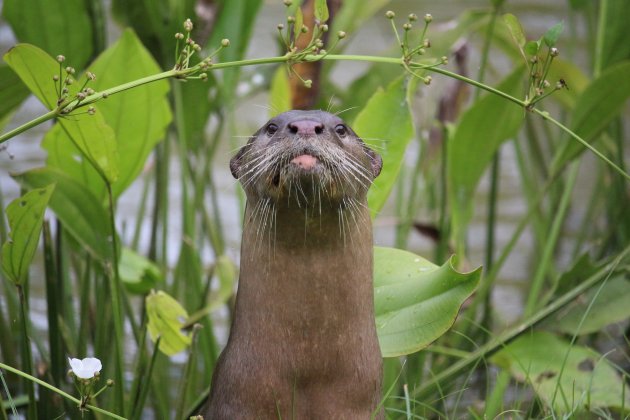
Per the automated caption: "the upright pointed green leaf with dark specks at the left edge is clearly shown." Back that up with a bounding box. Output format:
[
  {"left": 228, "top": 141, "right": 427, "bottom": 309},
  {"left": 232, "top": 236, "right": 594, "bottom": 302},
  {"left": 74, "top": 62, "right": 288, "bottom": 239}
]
[{"left": 2, "top": 184, "right": 55, "bottom": 284}]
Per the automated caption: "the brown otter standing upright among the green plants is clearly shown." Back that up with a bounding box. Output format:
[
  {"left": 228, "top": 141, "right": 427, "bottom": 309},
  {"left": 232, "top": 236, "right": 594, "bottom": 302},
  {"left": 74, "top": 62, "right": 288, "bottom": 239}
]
[{"left": 201, "top": 111, "right": 383, "bottom": 420}]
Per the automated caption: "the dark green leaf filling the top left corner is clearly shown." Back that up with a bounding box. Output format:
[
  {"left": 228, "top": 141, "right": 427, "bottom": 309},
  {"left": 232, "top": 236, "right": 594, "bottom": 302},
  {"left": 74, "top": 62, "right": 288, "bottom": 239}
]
[{"left": 3, "top": 0, "right": 93, "bottom": 69}]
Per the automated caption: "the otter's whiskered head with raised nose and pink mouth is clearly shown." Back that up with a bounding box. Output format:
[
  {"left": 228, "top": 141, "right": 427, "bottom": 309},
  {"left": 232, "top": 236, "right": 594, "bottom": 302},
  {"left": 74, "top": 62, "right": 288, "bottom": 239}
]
[{"left": 230, "top": 111, "right": 383, "bottom": 204}]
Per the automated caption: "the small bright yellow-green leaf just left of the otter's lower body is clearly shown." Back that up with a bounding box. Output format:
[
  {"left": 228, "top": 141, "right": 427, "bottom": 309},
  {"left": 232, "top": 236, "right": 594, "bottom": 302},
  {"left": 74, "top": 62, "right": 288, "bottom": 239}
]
[{"left": 145, "top": 291, "right": 191, "bottom": 356}]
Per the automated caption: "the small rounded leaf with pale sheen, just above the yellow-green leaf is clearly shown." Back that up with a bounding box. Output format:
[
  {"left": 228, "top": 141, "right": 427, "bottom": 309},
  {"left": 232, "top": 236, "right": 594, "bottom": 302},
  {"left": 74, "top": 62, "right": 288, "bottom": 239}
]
[{"left": 118, "top": 248, "right": 164, "bottom": 294}]
